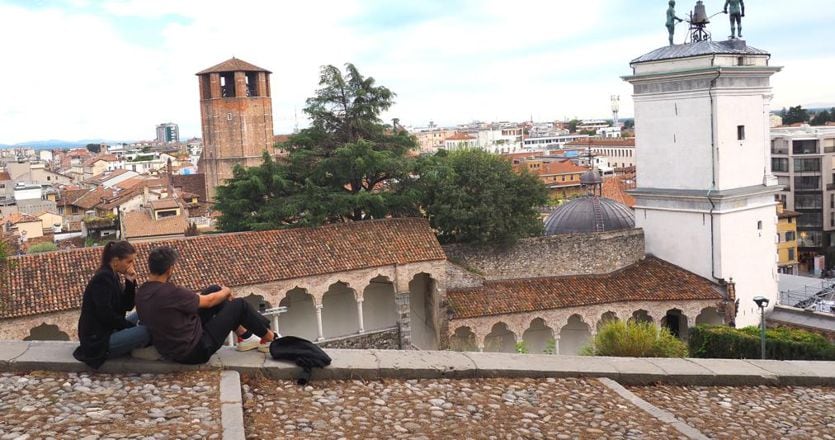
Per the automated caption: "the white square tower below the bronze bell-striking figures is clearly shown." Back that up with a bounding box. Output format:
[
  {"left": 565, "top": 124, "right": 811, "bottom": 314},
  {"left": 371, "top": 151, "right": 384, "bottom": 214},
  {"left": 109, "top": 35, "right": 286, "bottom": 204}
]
[{"left": 624, "top": 40, "right": 780, "bottom": 327}]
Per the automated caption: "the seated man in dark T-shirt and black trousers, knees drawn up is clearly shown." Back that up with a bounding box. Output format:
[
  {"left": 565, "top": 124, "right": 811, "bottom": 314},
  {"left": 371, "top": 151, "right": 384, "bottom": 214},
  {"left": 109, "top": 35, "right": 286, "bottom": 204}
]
[{"left": 136, "top": 246, "right": 275, "bottom": 364}]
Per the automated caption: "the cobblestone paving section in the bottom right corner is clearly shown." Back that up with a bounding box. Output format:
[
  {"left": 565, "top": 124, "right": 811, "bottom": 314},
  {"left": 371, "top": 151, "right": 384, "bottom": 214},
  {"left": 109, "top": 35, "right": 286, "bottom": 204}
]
[{"left": 630, "top": 385, "right": 835, "bottom": 440}]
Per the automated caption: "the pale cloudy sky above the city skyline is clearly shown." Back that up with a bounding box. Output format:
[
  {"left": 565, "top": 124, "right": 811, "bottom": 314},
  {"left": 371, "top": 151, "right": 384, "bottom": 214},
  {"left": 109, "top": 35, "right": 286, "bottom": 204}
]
[{"left": 0, "top": 0, "right": 835, "bottom": 144}]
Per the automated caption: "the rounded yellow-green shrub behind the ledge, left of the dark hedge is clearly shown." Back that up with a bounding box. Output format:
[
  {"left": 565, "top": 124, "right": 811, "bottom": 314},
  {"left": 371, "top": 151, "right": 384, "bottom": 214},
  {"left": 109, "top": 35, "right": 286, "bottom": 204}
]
[{"left": 581, "top": 321, "right": 687, "bottom": 357}]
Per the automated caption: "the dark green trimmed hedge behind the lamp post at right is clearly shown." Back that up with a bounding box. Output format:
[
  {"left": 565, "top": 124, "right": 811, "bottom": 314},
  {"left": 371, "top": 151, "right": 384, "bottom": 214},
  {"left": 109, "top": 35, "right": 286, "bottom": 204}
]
[{"left": 690, "top": 325, "right": 835, "bottom": 360}]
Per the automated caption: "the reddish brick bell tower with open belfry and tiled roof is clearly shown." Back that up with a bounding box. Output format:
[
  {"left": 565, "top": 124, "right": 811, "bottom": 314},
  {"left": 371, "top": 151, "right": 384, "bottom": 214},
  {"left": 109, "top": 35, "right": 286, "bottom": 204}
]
[{"left": 197, "top": 58, "right": 274, "bottom": 202}]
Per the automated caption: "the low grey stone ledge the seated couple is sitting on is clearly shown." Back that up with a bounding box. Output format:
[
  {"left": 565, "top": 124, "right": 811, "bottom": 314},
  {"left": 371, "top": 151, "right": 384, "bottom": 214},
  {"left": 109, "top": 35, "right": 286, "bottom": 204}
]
[{"left": 0, "top": 342, "right": 835, "bottom": 386}]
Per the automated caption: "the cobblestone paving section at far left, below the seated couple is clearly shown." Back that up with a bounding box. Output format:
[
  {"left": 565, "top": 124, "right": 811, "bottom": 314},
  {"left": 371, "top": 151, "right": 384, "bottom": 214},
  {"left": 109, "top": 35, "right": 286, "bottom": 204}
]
[{"left": 0, "top": 372, "right": 221, "bottom": 440}]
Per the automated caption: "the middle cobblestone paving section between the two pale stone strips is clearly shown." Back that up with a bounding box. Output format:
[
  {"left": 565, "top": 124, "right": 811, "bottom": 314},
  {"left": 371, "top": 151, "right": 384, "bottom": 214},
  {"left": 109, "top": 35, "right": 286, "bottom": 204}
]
[{"left": 242, "top": 377, "right": 681, "bottom": 440}]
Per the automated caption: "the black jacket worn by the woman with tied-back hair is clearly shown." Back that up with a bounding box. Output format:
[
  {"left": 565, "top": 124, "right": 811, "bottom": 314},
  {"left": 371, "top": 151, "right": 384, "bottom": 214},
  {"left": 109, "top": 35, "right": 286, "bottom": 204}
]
[{"left": 73, "top": 266, "right": 136, "bottom": 368}]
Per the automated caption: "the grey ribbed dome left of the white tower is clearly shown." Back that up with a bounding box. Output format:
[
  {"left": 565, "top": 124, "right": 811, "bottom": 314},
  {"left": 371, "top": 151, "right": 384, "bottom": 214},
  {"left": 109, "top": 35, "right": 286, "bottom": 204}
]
[{"left": 545, "top": 196, "right": 635, "bottom": 235}]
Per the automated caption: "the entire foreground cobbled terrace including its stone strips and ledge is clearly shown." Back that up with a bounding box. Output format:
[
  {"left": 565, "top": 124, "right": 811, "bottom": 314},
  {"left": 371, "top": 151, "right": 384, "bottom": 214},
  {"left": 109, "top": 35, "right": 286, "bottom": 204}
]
[{"left": 0, "top": 342, "right": 835, "bottom": 440}]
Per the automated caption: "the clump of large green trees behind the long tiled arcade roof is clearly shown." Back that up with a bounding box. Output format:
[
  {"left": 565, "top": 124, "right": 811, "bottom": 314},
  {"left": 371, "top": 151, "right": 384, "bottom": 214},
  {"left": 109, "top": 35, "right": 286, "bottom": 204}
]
[{"left": 215, "top": 64, "right": 546, "bottom": 243}]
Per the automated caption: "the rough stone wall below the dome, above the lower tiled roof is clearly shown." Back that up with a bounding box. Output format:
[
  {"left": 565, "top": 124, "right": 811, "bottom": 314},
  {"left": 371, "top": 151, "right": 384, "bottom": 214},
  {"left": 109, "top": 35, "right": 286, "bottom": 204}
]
[{"left": 444, "top": 229, "right": 644, "bottom": 280}]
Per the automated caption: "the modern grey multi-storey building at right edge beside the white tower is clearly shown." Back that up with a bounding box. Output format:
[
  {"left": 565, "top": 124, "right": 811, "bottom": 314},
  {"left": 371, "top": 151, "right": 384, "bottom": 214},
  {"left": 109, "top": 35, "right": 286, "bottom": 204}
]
[{"left": 771, "top": 126, "right": 835, "bottom": 272}]
